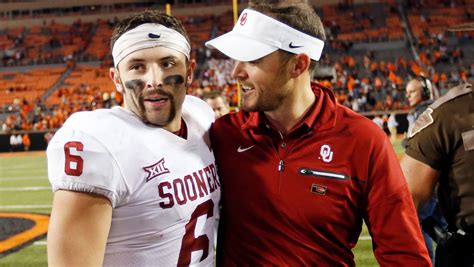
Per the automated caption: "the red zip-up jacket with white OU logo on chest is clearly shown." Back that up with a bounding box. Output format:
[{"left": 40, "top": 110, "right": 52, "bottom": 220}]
[{"left": 211, "top": 84, "right": 431, "bottom": 266}]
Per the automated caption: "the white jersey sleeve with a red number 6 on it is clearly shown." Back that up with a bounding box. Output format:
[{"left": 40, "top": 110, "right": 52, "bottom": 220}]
[{"left": 46, "top": 127, "right": 128, "bottom": 208}]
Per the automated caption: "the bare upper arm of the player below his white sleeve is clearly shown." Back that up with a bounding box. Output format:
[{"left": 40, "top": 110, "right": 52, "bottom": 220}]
[{"left": 48, "top": 190, "right": 112, "bottom": 266}]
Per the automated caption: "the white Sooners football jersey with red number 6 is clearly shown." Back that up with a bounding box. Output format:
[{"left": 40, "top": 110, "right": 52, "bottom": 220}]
[{"left": 47, "top": 96, "right": 220, "bottom": 266}]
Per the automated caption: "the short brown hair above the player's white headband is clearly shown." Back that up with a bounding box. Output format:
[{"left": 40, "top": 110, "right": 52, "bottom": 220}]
[{"left": 110, "top": 10, "right": 191, "bottom": 51}]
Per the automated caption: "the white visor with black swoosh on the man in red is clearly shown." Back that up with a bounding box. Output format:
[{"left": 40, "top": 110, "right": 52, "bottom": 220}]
[{"left": 206, "top": 9, "right": 324, "bottom": 62}]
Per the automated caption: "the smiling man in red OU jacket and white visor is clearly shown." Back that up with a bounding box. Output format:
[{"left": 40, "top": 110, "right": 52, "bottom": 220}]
[{"left": 206, "top": 1, "right": 431, "bottom": 266}]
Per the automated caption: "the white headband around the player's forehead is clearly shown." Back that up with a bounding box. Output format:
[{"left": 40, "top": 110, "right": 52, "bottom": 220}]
[{"left": 112, "top": 23, "right": 191, "bottom": 68}]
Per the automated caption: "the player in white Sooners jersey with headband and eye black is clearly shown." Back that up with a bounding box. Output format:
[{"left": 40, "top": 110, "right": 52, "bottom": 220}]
[{"left": 47, "top": 11, "right": 220, "bottom": 266}]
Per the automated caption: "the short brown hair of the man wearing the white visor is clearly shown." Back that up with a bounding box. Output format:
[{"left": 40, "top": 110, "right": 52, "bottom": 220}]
[{"left": 249, "top": 0, "right": 326, "bottom": 72}]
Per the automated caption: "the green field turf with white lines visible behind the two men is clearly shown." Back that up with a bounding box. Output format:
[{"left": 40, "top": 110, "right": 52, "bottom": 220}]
[{"left": 0, "top": 151, "right": 388, "bottom": 266}]
